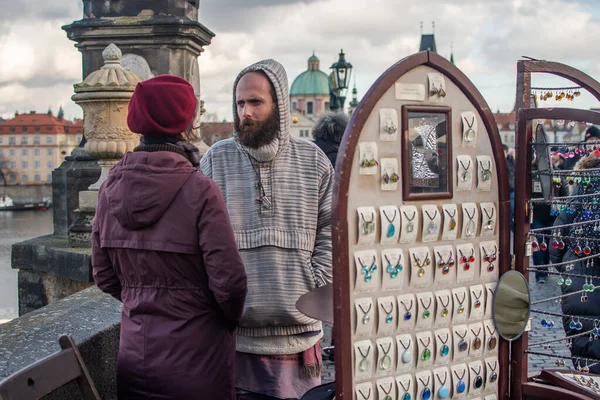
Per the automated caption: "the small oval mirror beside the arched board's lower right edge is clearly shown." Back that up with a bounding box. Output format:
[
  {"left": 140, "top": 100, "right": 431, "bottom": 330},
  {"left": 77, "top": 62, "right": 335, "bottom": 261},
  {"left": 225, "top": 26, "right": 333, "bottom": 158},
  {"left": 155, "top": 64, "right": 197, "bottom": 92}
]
[{"left": 492, "top": 270, "right": 531, "bottom": 341}]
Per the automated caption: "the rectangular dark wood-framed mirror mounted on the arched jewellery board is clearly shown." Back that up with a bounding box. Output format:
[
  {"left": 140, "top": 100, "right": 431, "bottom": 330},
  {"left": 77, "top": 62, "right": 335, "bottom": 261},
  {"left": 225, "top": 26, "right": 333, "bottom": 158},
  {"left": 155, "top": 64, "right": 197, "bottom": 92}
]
[{"left": 402, "top": 106, "right": 453, "bottom": 200}]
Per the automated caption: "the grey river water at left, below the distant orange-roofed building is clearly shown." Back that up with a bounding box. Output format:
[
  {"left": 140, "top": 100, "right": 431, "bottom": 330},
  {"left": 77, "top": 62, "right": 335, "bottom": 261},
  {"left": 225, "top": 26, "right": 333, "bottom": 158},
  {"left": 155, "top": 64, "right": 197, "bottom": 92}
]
[{"left": 0, "top": 186, "right": 53, "bottom": 323}]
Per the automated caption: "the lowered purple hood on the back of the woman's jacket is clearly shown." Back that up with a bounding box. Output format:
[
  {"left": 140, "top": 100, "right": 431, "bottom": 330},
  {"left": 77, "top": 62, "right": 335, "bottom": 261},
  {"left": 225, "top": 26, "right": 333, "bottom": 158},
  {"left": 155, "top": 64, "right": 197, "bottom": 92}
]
[{"left": 102, "top": 151, "right": 198, "bottom": 230}]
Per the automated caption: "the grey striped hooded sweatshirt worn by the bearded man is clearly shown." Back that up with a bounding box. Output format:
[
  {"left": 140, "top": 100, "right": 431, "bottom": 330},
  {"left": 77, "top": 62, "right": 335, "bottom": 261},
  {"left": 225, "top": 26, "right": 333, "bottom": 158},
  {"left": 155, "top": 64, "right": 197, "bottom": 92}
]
[{"left": 201, "top": 60, "right": 333, "bottom": 354}]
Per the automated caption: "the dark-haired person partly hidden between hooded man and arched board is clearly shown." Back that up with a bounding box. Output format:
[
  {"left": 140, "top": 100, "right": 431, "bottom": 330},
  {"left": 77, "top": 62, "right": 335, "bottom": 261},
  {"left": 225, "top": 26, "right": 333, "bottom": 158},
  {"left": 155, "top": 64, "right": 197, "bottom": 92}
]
[{"left": 312, "top": 111, "right": 348, "bottom": 168}]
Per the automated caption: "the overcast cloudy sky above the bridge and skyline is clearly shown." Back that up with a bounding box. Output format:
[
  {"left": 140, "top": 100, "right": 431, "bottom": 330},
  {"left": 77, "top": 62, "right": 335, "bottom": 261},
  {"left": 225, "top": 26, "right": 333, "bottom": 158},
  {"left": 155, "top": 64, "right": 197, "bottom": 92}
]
[{"left": 0, "top": 0, "right": 600, "bottom": 119}]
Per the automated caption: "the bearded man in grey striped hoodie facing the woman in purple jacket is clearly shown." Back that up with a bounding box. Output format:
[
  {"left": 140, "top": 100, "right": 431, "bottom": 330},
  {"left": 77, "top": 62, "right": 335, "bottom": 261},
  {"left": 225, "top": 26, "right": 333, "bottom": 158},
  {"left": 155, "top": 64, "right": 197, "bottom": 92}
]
[{"left": 201, "top": 60, "right": 333, "bottom": 400}]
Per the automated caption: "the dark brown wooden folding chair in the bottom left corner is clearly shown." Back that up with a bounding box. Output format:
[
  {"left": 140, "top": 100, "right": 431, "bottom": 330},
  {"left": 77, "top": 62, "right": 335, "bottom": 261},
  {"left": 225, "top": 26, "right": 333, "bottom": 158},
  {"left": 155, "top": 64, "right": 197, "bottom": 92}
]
[{"left": 0, "top": 335, "right": 100, "bottom": 400}]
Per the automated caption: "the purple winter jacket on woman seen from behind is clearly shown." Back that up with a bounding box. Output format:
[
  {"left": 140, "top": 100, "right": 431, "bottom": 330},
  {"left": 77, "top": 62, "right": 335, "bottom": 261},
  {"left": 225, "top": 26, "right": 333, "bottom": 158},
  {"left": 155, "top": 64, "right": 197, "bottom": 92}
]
[{"left": 92, "top": 151, "right": 247, "bottom": 399}]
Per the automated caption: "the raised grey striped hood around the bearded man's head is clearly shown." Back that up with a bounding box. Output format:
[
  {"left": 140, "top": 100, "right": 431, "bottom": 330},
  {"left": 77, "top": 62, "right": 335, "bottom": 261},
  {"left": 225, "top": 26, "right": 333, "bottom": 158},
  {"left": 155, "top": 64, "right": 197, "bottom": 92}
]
[{"left": 233, "top": 59, "right": 291, "bottom": 151}]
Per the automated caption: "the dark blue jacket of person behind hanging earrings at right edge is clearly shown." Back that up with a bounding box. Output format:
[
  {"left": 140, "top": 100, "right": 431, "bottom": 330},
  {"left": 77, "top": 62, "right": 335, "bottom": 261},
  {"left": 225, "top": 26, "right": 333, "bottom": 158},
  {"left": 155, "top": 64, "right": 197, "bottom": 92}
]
[{"left": 549, "top": 156, "right": 600, "bottom": 374}]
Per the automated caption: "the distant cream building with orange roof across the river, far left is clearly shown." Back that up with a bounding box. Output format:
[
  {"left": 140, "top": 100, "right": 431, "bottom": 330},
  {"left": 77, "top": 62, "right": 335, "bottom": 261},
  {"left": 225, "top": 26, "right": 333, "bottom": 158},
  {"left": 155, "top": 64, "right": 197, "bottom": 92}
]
[{"left": 0, "top": 108, "right": 83, "bottom": 185}]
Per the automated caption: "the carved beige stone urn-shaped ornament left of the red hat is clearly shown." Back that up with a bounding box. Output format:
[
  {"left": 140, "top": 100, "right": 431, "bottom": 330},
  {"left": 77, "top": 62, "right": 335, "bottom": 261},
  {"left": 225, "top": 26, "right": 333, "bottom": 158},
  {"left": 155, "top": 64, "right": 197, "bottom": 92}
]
[{"left": 72, "top": 44, "right": 141, "bottom": 190}]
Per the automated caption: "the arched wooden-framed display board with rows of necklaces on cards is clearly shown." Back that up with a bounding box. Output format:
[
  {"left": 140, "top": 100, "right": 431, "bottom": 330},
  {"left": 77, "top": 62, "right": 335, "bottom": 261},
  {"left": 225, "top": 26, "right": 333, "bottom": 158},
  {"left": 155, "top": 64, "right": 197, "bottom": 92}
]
[{"left": 332, "top": 52, "right": 510, "bottom": 400}]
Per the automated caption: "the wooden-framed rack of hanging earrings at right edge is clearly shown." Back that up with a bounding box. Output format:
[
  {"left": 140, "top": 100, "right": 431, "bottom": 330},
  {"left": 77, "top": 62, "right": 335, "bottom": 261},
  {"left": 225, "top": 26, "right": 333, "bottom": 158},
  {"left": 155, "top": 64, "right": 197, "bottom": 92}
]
[{"left": 511, "top": 60, "right": 600, "bottom": 399}]
